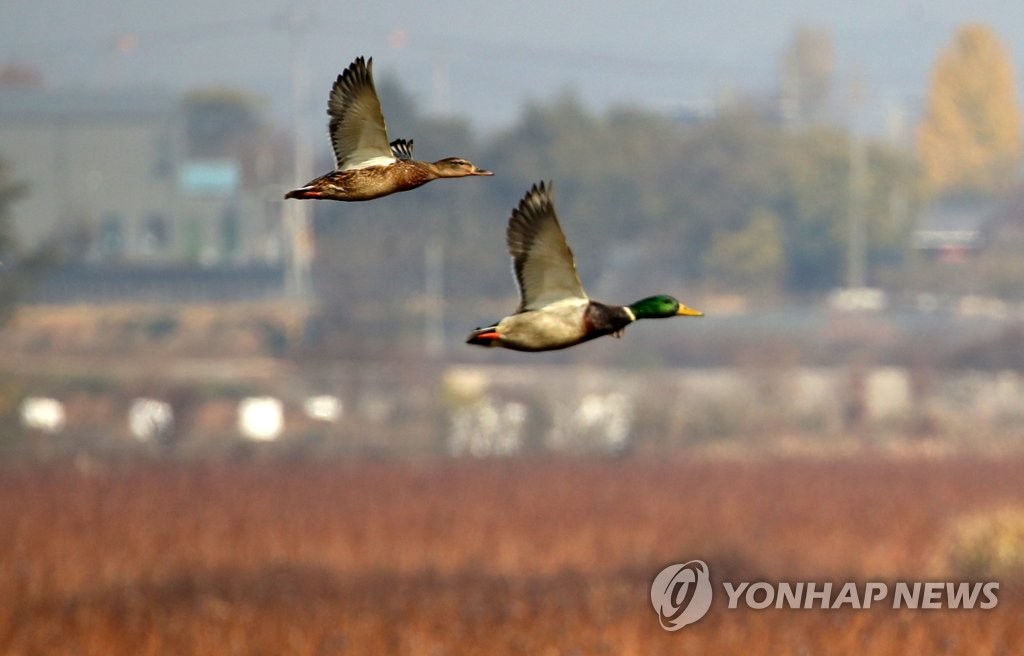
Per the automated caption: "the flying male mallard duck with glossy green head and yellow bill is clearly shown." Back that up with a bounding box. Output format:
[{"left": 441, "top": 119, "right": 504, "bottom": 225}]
[{"left": 466, "top": 182, "right": 703, "bottom": 351}]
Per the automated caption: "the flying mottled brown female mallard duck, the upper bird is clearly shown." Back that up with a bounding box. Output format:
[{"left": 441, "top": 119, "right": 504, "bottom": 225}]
[{"left": 285, "top": 57, "right": 494, "bottom": 201}]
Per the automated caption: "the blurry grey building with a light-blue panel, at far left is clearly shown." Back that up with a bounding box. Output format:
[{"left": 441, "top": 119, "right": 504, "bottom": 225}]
[{"left": 0, "top": 87, "right": 284, "bottom": 267}]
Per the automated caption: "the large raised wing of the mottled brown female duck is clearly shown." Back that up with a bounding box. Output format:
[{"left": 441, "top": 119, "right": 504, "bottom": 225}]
[{"left": 327, "top": 57, "right": 395, "bottom": 171}]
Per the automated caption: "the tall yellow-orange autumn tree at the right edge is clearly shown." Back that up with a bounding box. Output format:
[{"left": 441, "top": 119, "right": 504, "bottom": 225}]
[{"left": 918, "top": 24, "right": 1021, "bottom": 196}]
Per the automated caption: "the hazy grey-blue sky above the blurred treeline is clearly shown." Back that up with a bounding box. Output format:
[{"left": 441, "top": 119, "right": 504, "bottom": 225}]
[{"left": 0, "top": 0, "right": 1024, "bottom": 137}]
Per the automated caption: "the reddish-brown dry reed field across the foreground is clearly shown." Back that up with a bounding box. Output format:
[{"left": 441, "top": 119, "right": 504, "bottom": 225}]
[{"left": 0, "top": 456, "right": 1024, "bottom": 656}]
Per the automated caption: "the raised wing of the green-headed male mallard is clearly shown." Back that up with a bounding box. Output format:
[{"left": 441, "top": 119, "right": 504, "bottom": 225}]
[{"left": 506, "top": 182, "right": 588, "bottom": 312}]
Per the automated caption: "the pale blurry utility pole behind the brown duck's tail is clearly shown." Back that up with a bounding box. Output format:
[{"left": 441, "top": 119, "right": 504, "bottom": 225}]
[{"left": 285, "top": 9, "right": 313, "bottom": 300}]
